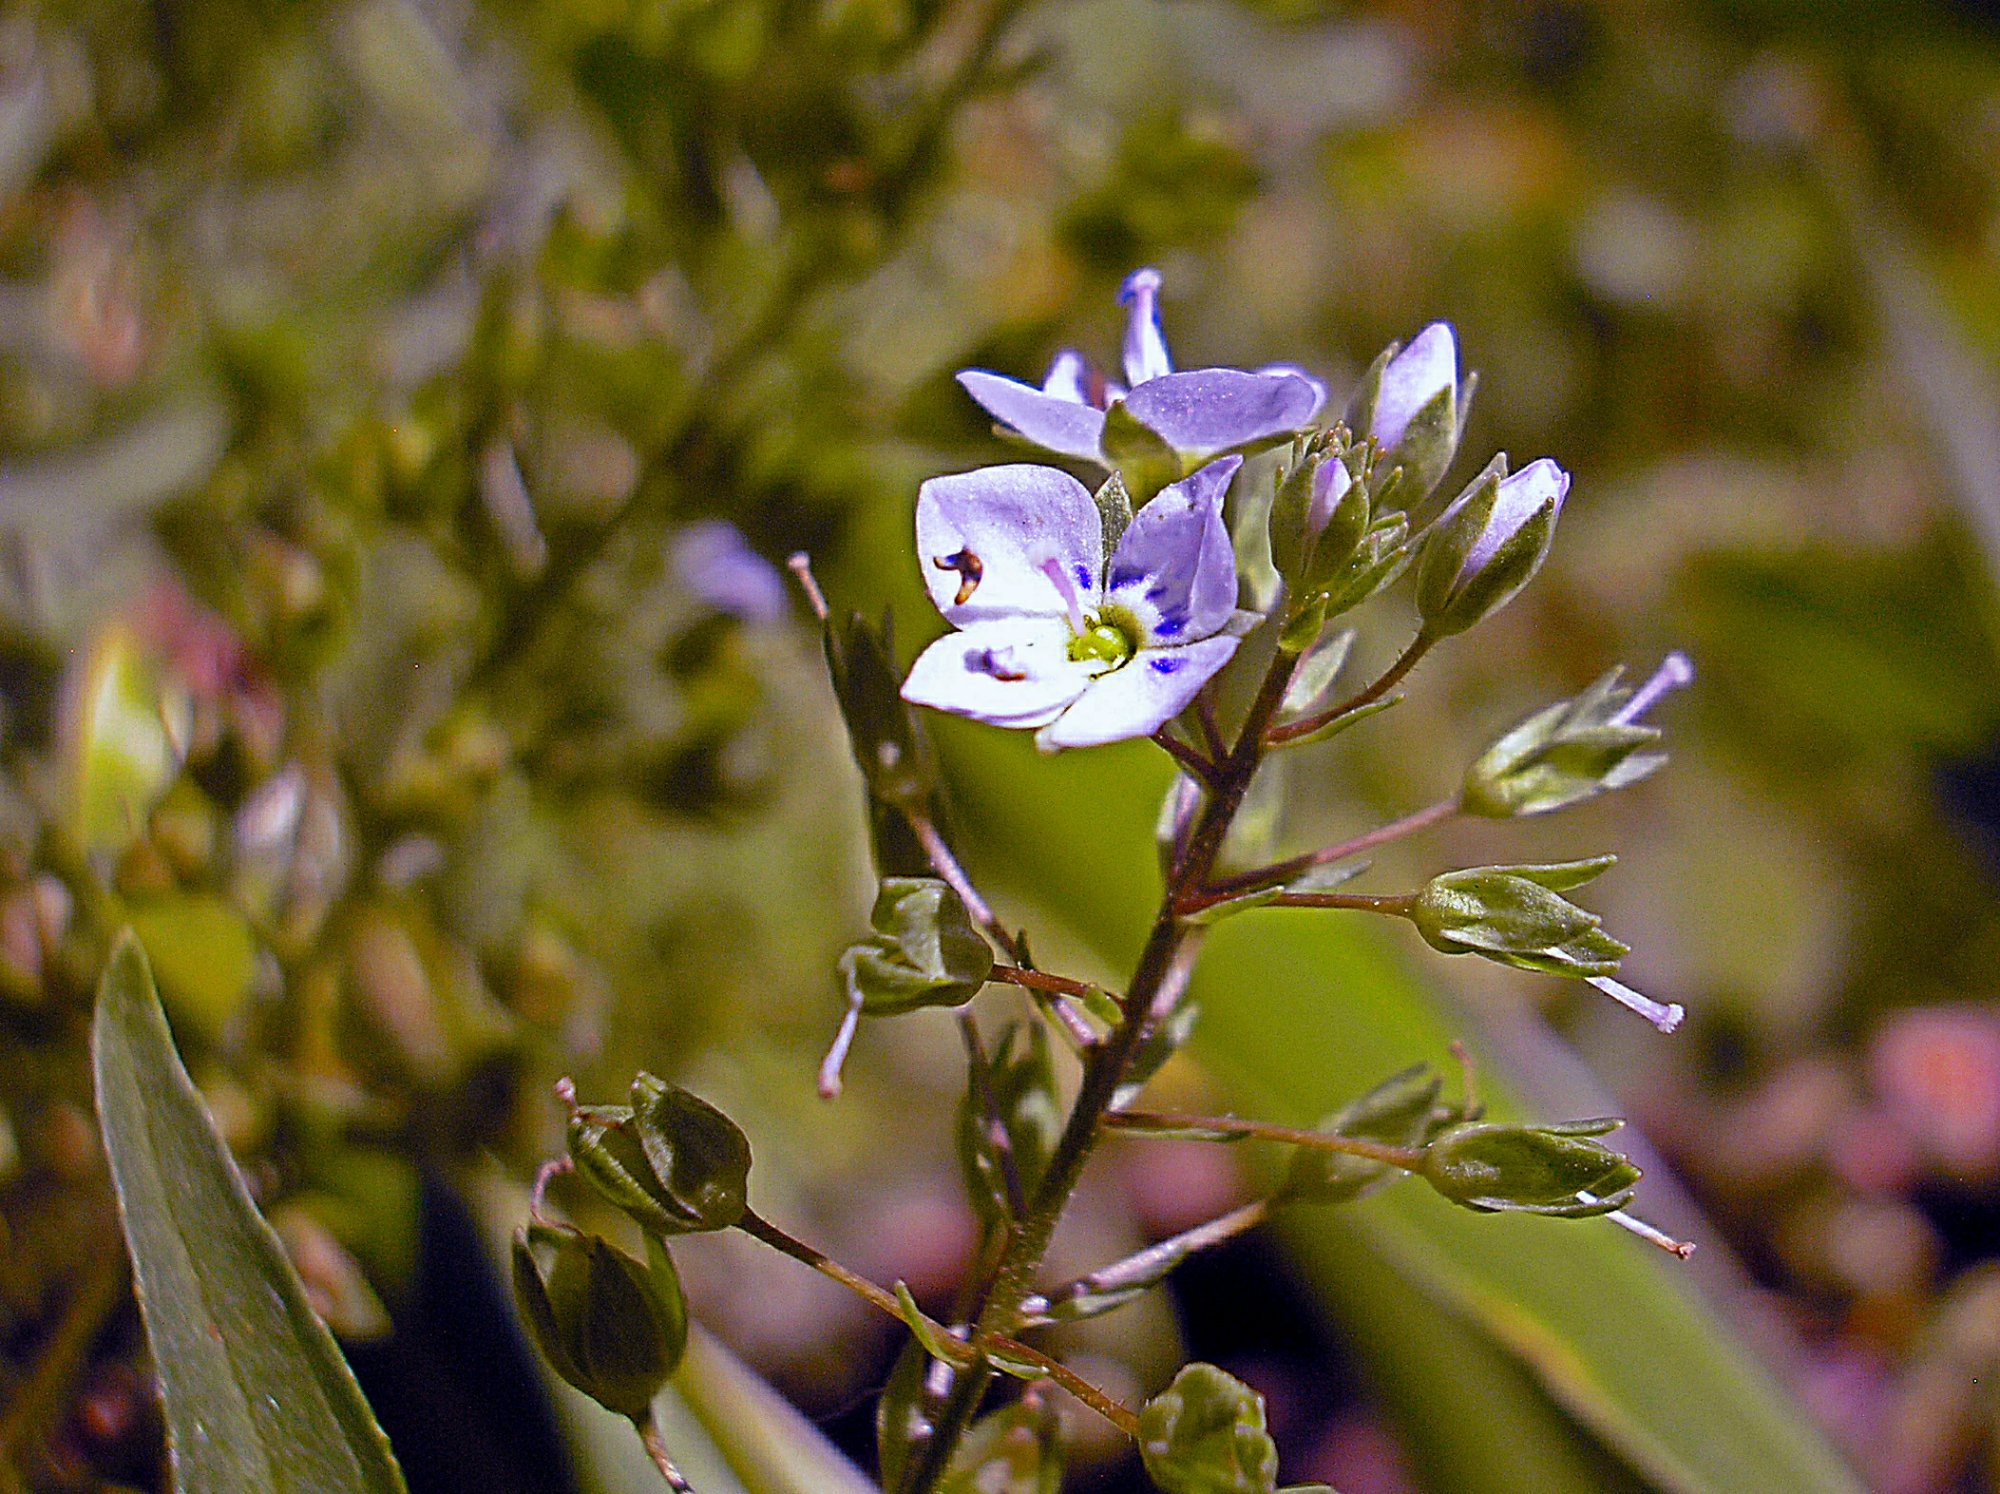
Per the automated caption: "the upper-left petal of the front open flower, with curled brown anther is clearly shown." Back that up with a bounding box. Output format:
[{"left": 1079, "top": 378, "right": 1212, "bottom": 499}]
[{"left": 916, "top": 462, "right": 1104, "bottom": 624}]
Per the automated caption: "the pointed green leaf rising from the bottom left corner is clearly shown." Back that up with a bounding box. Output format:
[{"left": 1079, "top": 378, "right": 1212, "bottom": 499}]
[{"left": 92, "top": 934, "right": 404, "bottom": 1494}]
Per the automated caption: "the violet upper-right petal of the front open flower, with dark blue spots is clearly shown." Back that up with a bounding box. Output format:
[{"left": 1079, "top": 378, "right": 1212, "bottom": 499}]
[{"left": 1104, "top": 456, "right": 1242, "bottom": 644}]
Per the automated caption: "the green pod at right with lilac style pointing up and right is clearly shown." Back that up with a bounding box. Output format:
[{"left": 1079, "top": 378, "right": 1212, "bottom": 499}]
[{"left": 1458, "top": 654, "right": 1692, "bottom": 820}]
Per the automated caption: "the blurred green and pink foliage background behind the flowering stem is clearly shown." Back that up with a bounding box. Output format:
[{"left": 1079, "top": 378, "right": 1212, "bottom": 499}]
[{"left": 0, "top": 0, "right": 2000, "bottom": 1494}]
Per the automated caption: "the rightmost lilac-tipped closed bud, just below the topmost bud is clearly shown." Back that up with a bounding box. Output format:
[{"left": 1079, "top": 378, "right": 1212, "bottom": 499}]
[{"left": 1416, "top": 456, "right": 1570, "bottom": 638}]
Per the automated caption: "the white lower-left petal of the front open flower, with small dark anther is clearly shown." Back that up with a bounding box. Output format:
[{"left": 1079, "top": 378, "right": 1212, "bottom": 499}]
[{"left": 902, "top": 618, "right": 1102, "bottom": 726}]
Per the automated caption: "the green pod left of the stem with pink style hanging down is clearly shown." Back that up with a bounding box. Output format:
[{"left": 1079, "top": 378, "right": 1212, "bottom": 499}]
[{"left": 840, "top": 876, "right": 994, "bottom": 1016}]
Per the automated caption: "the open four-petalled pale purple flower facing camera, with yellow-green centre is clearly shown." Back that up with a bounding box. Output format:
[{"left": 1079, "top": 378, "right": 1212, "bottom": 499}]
[{"left": 902, "top": 456, "right": 1256, "bottom": 750}]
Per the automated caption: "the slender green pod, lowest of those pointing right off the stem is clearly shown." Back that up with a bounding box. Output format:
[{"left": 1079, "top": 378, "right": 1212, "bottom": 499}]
[{"left": 1424, "top": 1120, "right": 1640, "bottom": 1218}]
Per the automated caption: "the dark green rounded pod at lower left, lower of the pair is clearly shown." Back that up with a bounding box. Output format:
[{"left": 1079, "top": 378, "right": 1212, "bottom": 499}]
[{"left": 514, "top": 1222, "right": 688, "bottom": 1422}]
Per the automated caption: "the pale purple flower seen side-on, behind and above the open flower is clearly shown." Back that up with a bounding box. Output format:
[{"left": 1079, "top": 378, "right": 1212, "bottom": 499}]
[{"left": 958, "top": 270, "right": 1326, "bottom": 468}]
